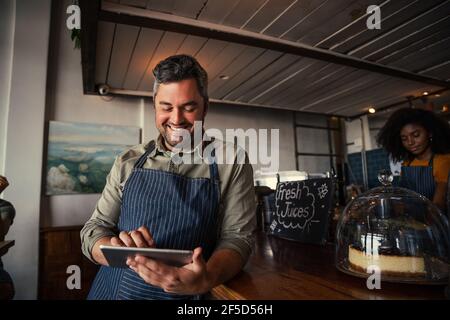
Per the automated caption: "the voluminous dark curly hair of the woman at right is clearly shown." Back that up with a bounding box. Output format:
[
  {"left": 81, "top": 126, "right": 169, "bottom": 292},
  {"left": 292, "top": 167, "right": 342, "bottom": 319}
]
[{"left": 377, "top": 108, "right": 450, "bottom": 161}]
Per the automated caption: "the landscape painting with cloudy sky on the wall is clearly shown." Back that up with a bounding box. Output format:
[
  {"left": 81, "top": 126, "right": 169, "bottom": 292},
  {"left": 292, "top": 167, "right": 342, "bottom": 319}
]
[{"left": 46, "top": 121, "right": 140, "bottom": 195}]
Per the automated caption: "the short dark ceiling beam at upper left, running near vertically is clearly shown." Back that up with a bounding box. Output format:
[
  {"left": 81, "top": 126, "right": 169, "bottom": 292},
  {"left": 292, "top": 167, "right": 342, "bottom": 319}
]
[{"left": 79, "top": 0, "right": 100, "bottom": 94}]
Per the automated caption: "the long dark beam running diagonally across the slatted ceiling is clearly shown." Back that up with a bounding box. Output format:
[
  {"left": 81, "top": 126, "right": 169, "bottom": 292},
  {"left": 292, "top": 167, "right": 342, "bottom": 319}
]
[{"left": 99, "top": 1, "right": 450, "bottom": 88}]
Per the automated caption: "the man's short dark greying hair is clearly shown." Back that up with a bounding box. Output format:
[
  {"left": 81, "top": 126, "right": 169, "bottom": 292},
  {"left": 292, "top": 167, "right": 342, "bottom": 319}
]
[{"left": 153, "top": 54, "right": 209, "bottom": 106}]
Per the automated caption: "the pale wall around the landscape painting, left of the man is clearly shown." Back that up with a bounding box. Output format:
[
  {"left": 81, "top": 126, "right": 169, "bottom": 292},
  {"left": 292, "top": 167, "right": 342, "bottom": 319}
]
[{"left": 41, "top": 0, "right": 143, "bottom": 227}]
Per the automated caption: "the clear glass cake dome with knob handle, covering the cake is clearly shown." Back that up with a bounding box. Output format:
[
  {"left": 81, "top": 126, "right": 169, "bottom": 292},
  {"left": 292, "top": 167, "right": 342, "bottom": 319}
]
[{"left": 336, "top": 171, "right": 450, "bottom": 284}]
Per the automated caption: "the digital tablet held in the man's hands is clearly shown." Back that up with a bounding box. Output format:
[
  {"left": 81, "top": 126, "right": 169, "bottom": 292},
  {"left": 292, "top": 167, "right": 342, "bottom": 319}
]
[{"left": 100, "top": 245, "right": 193, "bottom": 268}]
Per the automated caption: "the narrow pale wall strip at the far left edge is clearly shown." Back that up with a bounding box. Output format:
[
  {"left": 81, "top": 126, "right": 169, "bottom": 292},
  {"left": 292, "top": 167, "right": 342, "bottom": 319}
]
[{"left": 0, "top": 0, "right": 16, "bottom": 174}]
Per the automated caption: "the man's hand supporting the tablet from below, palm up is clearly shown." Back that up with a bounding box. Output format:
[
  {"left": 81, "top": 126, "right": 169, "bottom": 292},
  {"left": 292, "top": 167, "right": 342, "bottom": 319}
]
[{"left": 127, "top": 247, "right": 214, "bottom": 295}]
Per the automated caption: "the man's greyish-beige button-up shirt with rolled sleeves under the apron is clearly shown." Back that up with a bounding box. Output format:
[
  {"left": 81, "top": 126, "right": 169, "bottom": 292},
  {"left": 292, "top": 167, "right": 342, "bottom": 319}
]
[{"left": 81, "top": 136, "right": 256, "bottom": 262}]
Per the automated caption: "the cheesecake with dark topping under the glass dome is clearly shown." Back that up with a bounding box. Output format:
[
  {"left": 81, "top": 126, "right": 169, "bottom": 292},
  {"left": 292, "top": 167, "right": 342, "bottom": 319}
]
[{"left": 348, "top": 246, "right": 426, "bottom": 277}]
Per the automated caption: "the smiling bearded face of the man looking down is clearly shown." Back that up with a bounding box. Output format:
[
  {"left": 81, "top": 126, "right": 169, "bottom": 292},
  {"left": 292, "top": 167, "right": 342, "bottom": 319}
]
[{"left": 154, "top": 79, "right": 206, "bottom": 150}]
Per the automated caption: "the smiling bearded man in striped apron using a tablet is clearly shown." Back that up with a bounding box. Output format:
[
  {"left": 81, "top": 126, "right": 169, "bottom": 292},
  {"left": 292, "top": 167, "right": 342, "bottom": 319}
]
[{"left": 81, "top": 55, "right": 256, "bottom": 299}]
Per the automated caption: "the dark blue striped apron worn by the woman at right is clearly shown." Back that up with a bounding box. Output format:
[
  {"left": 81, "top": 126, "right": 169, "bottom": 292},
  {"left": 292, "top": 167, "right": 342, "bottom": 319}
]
[{"left": 400, "top": 155, "right": 436, "bottom": 200}]
